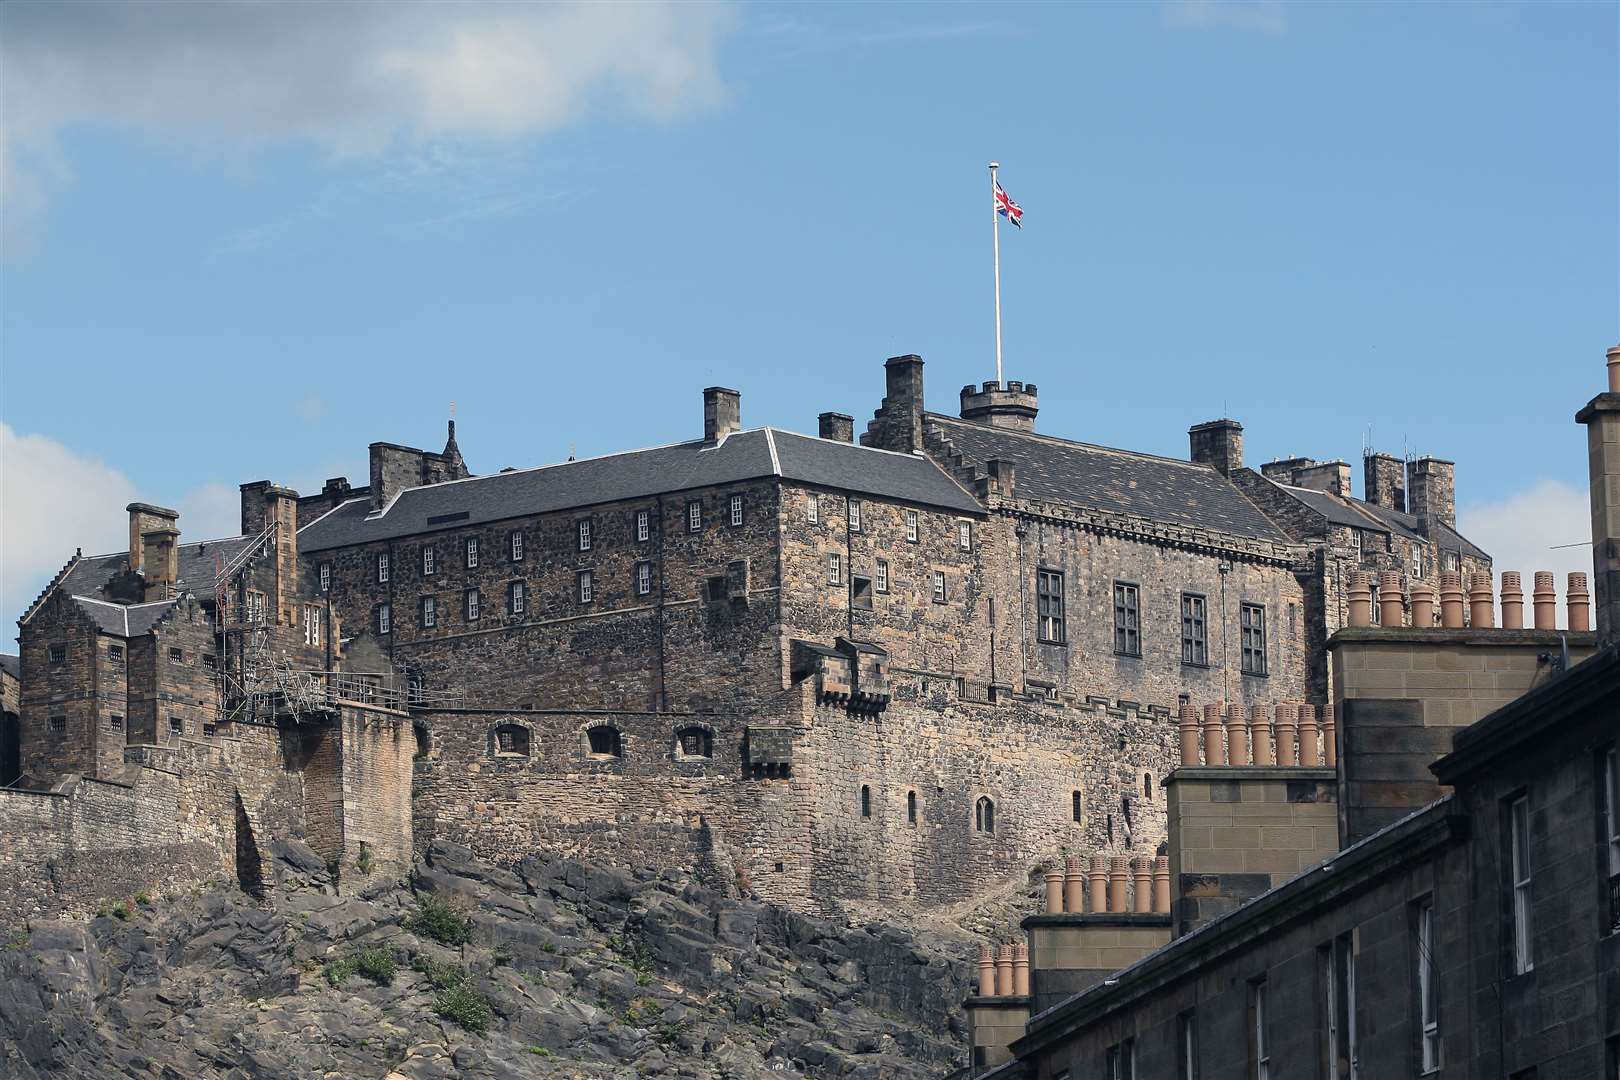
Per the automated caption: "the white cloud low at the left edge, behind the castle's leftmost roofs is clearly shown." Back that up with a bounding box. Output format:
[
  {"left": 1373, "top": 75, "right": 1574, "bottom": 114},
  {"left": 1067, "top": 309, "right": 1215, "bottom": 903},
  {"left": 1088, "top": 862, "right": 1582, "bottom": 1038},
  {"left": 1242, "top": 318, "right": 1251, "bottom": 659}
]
[{"left": 0, "top": 423, "right": 240, "bottom": 637}]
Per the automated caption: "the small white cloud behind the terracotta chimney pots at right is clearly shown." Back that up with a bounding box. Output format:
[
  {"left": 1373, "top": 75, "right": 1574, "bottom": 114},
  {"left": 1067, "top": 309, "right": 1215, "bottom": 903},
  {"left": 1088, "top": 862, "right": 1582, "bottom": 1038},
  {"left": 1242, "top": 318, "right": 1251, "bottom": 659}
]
[{"left": 1456, "top": 479, "right": 1592, "bottom": 627}]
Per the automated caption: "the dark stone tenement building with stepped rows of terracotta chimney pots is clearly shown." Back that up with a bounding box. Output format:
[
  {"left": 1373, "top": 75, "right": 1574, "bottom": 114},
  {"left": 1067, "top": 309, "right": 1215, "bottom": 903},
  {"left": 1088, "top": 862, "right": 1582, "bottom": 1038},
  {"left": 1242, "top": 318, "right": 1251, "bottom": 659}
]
[{"left": 967, "top": 348, "right": 1620, "bottom": 1080}]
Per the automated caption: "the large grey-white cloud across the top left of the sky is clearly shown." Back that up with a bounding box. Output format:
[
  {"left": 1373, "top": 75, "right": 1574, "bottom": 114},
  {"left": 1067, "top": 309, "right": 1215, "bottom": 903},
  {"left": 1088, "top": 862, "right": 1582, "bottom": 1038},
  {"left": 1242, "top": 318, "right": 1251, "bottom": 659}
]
[{"left": 0, "top": 0, "right": 735, "bottom": 244}]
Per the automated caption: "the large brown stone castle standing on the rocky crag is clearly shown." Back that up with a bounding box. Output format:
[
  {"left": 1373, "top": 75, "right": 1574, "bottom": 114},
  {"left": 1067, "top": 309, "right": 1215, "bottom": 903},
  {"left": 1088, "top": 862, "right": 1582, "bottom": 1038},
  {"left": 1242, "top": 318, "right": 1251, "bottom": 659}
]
[{"left": 0, "top": 356, "right": 1490, "bottom": 910}]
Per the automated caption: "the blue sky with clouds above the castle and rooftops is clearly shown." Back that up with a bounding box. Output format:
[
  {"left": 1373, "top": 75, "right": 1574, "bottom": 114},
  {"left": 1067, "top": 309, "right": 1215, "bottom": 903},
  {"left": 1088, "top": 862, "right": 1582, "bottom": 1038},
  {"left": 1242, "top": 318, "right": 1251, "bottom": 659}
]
[{"left": 0, "top": 2, "right": 1620, "bottom": 636}]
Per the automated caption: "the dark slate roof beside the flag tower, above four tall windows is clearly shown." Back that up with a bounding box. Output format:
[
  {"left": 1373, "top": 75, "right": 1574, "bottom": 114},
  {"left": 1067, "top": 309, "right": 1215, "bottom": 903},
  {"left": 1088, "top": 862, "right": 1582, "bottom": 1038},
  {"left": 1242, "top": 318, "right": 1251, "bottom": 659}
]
[{"left": 927, "top": 413, "right": 1288, "bottom": 542}]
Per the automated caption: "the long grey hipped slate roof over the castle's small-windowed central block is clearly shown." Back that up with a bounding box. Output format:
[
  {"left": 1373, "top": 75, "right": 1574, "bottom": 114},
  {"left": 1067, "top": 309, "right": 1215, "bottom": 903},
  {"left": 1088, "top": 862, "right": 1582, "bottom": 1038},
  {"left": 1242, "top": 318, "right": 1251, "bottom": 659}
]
[{"left": 298, "top": 427, "right": 983, "bottom": 552}]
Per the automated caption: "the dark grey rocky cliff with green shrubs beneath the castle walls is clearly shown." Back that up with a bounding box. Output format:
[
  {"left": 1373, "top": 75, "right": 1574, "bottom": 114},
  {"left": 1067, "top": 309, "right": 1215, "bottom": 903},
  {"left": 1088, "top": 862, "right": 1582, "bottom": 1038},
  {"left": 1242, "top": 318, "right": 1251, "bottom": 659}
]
[{"left": 0, "top": 844, "right": 972, "bottom": 1080}]
